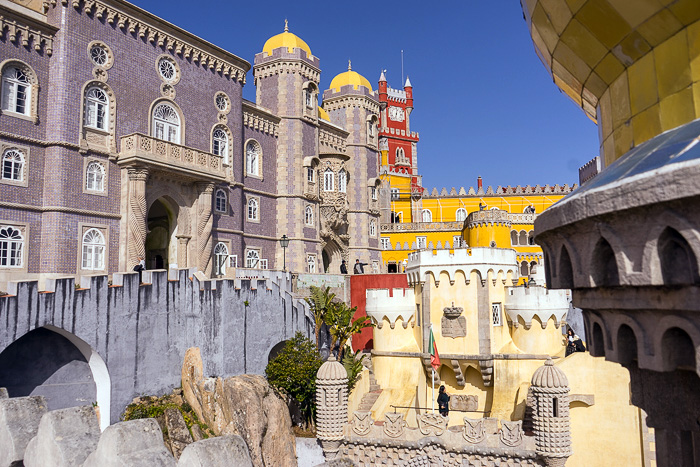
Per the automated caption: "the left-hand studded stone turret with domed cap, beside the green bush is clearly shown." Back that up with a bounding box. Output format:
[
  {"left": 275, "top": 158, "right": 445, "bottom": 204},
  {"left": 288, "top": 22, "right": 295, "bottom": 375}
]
[{"left": 316, "top": 354, "right": 348, "bottom": 460}]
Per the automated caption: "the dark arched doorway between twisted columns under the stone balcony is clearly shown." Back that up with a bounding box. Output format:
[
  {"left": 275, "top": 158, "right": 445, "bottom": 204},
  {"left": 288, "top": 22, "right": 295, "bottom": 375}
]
[{"left": 146, "top": 198, "right": 178, "bottom": 269}]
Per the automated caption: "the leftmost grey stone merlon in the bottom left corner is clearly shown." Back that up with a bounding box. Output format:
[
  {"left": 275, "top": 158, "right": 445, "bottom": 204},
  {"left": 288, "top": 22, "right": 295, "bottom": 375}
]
[{"left": 0, "top": 396, "right": 47, "bottom": 467}]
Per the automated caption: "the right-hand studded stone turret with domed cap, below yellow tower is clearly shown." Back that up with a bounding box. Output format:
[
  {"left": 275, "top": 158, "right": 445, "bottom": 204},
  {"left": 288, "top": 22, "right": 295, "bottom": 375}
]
[{"left": 530, "top": 358, "right": 573, "bottom": 467}]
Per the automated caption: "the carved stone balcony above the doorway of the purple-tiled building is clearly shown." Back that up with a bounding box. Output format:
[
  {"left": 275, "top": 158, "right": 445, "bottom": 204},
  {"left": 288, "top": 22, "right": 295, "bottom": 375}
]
[{"left": 117, "top": 133, "right": 226, "bottom": 182}]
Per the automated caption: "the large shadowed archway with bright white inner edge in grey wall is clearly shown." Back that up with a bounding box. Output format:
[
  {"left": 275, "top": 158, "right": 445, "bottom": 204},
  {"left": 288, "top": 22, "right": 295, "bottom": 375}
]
[{"left": 0, "top": 325, "right": 111, "bottom": 430}]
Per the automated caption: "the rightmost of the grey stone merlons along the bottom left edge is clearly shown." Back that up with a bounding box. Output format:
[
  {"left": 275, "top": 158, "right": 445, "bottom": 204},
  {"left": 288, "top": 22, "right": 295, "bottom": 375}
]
[{"left": 177, "top": 435, "right": 253, "bottom": 467}]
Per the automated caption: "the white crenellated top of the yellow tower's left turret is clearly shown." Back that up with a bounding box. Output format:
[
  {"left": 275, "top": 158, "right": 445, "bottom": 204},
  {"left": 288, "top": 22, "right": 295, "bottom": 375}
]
[{"left": 365, "top": 288, "right": 416, "bottom": 329}]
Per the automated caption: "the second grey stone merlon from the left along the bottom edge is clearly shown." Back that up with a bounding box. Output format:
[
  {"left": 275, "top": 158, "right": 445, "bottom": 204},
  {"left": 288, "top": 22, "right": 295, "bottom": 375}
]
[{"left": 24, "top": 405, "right": 100, "bottom": 467}]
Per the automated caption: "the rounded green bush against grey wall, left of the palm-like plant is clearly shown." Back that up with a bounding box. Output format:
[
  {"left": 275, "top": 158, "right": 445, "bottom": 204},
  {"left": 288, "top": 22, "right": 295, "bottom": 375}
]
[{"left": 265, "top": 332, "right": 323, "bottom": 426}]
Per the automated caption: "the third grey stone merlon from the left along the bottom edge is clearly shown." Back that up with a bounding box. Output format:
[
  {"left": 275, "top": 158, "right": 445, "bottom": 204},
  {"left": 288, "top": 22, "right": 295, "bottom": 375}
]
[{"left": 83, "top": 418, "right": 176, "bottom": 467}]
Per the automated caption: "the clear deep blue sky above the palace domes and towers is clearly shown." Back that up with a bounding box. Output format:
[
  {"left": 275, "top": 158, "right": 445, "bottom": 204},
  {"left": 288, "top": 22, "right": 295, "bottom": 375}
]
[{"left": 134, "top": 0, "right": 599, "bottom": 190}]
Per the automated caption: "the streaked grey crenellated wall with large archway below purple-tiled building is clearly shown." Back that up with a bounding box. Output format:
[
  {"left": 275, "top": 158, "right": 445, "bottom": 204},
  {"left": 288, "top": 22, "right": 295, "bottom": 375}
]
[{"left": 0, "top": 269, "right": 313, "bottom": 422}]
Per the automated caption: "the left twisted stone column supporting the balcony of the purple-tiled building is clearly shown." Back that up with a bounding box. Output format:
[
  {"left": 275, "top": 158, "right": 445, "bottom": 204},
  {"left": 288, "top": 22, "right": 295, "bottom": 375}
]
[{"left": 126, "top": 167, "right": 148, "bottom": 270}]
